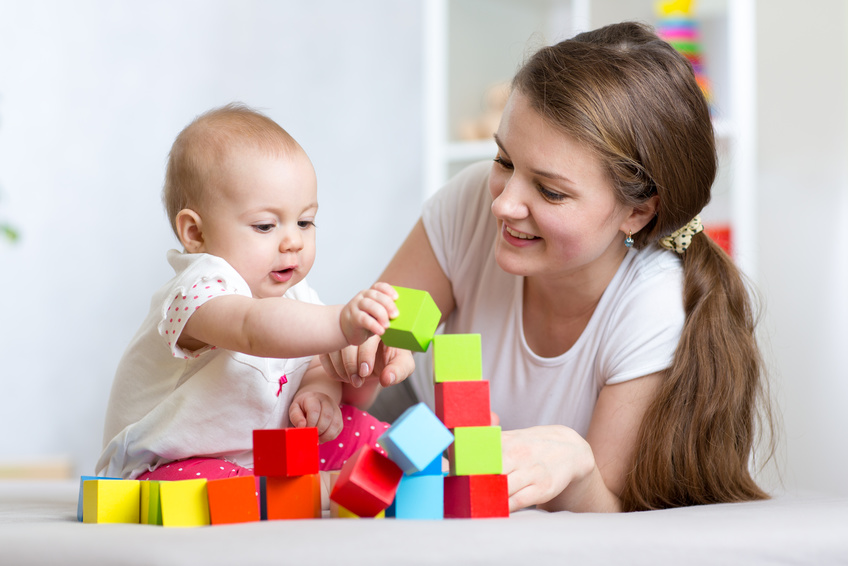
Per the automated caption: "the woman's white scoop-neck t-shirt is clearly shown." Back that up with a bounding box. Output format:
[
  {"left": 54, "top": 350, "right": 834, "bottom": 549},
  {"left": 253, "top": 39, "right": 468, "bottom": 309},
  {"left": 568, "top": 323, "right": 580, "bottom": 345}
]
[{"left": 410, "top": 163, "right": 685, "bottom": 435}]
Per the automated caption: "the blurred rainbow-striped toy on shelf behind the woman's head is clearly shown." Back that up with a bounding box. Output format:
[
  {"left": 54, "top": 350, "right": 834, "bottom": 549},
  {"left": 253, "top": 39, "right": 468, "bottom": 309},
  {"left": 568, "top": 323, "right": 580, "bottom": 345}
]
[{"left": 656, "top": 0, "right": 712, "bottom": 105}]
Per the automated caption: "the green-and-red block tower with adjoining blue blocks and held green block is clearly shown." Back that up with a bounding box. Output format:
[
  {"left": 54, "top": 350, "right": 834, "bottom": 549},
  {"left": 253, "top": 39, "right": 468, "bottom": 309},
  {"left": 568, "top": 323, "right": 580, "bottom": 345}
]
[{"left": 342, "top": 287, "right": 509, "bottom": 518}]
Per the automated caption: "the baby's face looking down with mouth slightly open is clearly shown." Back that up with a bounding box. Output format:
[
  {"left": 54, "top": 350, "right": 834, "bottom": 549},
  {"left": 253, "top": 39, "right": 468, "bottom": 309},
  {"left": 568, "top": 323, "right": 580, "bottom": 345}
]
[{"left": 195, "top": 146, "right": 318, "bottom": 298}]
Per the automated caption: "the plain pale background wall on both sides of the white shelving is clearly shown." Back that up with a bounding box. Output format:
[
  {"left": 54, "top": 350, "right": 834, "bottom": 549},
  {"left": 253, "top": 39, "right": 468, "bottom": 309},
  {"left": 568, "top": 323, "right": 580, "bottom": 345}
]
[{"left": 0, "top": 0, "right": 848, "bottom": 502}]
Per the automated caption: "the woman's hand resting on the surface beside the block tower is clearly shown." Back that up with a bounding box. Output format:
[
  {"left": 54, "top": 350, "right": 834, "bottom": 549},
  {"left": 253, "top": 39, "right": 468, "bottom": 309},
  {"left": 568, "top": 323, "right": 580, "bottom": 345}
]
[{"left": 502, "top": 425, "right": 618, "bottom": 511}]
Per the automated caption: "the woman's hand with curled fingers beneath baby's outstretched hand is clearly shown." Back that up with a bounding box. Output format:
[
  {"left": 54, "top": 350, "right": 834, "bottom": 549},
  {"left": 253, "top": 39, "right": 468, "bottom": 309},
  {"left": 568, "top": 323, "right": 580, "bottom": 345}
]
[{"left": 320, "top": 336, "right": 415, "bottom": 388}]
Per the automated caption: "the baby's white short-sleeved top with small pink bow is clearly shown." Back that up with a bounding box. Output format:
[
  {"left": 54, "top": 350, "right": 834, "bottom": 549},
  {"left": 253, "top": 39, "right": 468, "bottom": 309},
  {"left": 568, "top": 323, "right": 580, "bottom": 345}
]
[{"left": 97, "top": 250, "right": 321, "bottom": 478}]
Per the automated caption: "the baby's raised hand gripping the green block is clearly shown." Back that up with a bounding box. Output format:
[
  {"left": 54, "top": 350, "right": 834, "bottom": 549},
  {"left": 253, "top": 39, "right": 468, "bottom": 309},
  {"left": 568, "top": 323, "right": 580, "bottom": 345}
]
[{"left": 339, "top": 283, "right": 398, "bottom": 346}]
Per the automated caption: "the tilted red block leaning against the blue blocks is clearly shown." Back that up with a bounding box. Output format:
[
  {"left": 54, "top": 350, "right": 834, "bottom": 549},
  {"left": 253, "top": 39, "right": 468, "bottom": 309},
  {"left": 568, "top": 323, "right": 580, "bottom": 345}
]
[{"left": 330, "top": 445, "right": 403, "bottom": 517}]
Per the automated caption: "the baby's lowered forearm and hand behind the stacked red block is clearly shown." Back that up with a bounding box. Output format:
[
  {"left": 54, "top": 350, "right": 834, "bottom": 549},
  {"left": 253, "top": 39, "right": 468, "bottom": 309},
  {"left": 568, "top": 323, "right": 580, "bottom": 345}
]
[{"left": 289, "top": 357, "right": 342, "bottom": 442}]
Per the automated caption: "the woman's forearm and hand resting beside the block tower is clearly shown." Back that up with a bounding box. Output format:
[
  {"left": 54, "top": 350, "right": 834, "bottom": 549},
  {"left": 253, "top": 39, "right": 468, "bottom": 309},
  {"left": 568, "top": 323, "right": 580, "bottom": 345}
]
[{"left": 503, "top": 374, "right": 661, "bottom": 512}]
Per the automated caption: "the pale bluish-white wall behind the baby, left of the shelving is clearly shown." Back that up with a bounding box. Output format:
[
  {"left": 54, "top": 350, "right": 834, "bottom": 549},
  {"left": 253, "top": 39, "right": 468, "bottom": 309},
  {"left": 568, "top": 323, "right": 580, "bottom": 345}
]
[{"left": 0, "top": 0, "right": 422, "bottom": 480}]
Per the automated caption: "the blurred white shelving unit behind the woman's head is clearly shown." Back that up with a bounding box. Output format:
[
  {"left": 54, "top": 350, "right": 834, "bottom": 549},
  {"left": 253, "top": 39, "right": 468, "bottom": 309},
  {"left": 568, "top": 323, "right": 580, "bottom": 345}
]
[{"left": 422, "top": 0, "right": 757, "bottom": 279}]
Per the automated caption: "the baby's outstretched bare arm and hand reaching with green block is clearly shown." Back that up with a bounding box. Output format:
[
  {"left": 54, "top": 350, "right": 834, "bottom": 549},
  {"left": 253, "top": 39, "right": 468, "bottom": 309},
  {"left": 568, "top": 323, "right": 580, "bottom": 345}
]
[{"left": 178, "top": 283, "right": 397, "bottom": 358}]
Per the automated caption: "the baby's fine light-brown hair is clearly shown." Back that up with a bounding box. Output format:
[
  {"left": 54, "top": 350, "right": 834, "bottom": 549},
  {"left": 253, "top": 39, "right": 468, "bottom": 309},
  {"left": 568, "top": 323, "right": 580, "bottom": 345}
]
[{"left": 162, "top": 102, "right": 303, "bottom": 238}]
